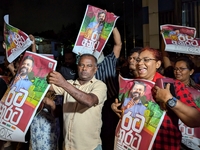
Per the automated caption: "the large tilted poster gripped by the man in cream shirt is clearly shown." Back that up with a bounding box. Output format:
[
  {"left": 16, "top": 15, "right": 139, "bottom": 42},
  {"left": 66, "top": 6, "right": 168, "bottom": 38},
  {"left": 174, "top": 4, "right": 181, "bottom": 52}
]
[{"left": 0, "top": 51, "right": 57, "bottom": 142}]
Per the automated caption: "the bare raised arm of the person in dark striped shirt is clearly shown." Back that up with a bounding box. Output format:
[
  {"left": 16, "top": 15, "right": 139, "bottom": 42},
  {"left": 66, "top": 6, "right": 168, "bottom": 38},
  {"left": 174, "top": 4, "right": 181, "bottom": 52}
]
[{"left": 113, "top": 27, "right": 122, "bottom": 58}]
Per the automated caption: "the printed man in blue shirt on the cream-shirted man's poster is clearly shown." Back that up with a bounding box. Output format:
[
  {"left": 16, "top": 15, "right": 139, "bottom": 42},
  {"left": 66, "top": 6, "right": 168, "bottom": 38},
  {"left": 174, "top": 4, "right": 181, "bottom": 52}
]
[{"left": 11, "top": 55, "right": 34, "bottom": 92}]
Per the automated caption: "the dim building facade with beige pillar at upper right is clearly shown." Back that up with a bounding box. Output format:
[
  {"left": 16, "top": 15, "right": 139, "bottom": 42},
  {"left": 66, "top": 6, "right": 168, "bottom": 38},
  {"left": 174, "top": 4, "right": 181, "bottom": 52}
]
[{"left": 142, "top": 0, "right": 200, "bottom": 49}]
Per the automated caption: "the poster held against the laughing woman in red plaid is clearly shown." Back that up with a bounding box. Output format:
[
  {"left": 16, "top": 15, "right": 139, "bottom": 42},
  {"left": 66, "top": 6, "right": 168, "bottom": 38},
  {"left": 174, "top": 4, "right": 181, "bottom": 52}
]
[{"left": 114, "top": 76, "right": 166, "bottom": 150}]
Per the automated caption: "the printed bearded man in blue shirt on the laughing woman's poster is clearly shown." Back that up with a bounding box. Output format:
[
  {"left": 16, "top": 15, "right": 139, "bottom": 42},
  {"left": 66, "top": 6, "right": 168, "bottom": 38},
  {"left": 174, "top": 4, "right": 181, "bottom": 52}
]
[{"left": 122, "top": 81, "right": 147, "bottom": 117}]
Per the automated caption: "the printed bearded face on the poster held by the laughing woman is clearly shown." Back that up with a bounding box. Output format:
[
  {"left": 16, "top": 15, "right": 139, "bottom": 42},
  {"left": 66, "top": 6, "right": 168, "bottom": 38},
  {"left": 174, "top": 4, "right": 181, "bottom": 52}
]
[{"left": 130, "top": 84, "right": 145, "bottom": 100}]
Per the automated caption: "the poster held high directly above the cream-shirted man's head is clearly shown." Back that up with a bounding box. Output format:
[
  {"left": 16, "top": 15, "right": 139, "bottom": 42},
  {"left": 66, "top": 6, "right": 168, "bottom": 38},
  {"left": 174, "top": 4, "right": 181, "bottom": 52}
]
[{"left": 73, "top": 5, "right": 119, "bottom": 59}]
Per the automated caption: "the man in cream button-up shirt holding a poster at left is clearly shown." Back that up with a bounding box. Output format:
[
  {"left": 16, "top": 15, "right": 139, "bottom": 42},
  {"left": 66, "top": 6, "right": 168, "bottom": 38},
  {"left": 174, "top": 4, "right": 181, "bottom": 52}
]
[{"left": 48, "top": 54, "right": 107, "bottom": 150}]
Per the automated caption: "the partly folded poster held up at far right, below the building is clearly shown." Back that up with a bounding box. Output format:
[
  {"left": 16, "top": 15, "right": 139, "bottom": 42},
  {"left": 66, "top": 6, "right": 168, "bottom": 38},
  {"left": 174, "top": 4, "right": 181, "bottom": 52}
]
[{"left": 160, "top": 24, "right": 200, "bottom": 55}]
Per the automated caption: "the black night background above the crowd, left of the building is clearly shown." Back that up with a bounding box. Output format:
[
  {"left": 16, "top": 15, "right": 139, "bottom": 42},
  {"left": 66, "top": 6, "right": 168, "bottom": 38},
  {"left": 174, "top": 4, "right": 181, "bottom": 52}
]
[{"left": 0, "top": 0, "right": 142, "bottom": 55}]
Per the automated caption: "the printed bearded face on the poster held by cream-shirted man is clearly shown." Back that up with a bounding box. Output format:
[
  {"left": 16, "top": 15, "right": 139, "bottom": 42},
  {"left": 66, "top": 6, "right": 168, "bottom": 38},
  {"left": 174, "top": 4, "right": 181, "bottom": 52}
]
[{"left": 20, "top": 59, "right": 33, "bottom": 76}]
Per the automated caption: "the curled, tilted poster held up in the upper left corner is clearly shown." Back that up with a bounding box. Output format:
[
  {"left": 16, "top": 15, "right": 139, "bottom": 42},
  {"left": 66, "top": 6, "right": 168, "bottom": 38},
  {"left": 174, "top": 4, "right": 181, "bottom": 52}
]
[{"left": 4, "top": 15, "right": 32, "bottom": 63}]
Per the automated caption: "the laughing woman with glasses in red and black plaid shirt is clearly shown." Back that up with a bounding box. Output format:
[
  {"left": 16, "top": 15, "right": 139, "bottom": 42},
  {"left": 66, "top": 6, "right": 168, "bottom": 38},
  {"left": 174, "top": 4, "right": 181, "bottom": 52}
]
[{"left": 111, "top": 47, "right": 200, "bottom": 150}]
